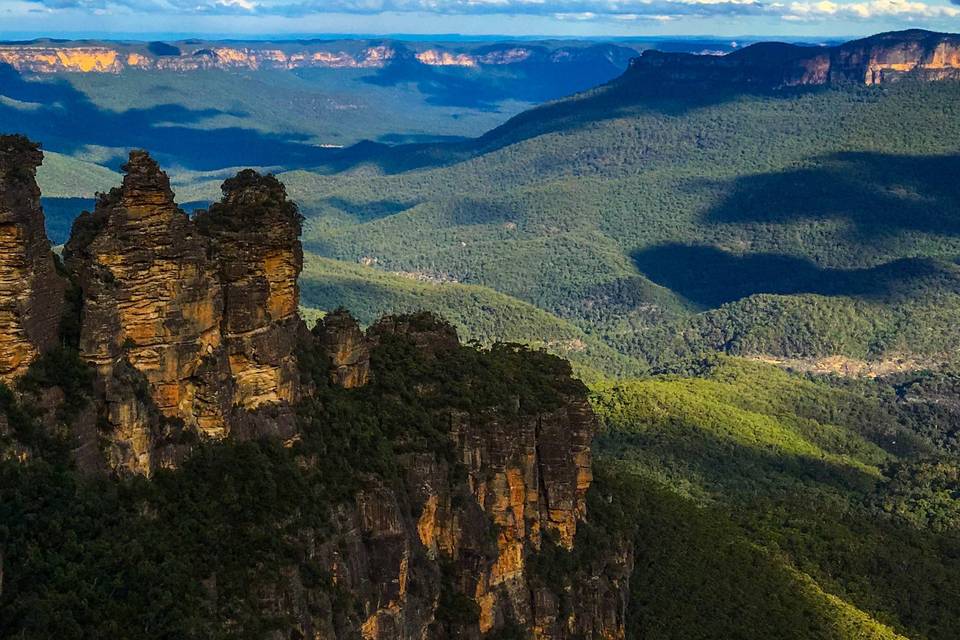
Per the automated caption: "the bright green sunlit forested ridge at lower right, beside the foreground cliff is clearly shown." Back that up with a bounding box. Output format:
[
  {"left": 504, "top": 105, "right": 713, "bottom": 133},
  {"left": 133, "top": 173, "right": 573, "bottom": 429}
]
[{"left": 593, "top": 358, "right": 960, "bottom": 640}]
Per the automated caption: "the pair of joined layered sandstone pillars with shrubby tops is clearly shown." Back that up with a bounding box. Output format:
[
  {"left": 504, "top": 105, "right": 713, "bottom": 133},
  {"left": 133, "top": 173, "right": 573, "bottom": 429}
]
[{"left": 64, "top": 151, "right": 303, "bottom": 474}]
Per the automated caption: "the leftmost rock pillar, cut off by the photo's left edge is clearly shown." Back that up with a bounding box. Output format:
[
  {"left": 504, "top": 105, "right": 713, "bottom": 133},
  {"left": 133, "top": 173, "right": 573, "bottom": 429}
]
[{"left": 0, "top": 136, "right": 65, "bottom": 383}]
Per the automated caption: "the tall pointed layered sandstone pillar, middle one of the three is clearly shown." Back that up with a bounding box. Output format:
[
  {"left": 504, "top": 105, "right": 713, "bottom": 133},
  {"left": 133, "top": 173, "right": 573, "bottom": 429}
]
[{"left": 64, "top": 151, "right": 232, "bottom": 472}]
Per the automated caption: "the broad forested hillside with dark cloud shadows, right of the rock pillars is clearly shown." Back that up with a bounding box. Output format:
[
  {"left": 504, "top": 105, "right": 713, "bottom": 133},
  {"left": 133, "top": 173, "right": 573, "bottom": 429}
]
[{"left": 284, "top": 32, "right": 960, "bottom": 366}]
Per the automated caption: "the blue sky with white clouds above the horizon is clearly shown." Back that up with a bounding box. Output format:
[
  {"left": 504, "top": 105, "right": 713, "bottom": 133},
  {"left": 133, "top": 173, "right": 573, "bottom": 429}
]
[{"left": 0, "top": 0, "right": 960, "bottom": 37}]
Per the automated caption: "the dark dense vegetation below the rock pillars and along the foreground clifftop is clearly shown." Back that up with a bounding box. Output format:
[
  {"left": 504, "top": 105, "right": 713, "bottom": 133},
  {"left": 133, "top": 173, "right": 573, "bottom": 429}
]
[{"left": 0, "top": 316, "right": 583, "bottom": 640}]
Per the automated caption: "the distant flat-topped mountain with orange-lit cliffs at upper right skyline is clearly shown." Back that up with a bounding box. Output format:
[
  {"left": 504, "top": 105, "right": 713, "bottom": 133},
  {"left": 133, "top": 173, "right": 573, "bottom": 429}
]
[{"left": 625, "top": 30, "right": 960, "bottom": 89}]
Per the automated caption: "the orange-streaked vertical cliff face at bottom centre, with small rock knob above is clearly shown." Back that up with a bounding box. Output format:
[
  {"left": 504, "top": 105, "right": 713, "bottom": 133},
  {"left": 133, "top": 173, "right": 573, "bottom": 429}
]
[{"left": 286, "top": 312, "right": 633, "bottom": 640}]
